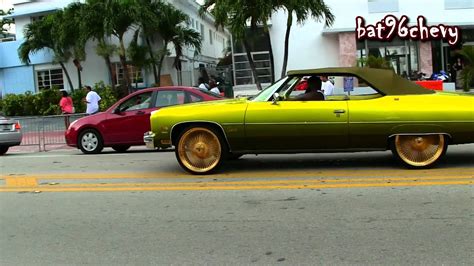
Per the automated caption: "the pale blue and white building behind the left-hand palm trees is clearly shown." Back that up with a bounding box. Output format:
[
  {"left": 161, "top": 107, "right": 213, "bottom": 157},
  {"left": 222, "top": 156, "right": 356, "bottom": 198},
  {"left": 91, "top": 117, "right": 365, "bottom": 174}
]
[{"left": 0, "top": 0, "right": 230, "bottom": 95}]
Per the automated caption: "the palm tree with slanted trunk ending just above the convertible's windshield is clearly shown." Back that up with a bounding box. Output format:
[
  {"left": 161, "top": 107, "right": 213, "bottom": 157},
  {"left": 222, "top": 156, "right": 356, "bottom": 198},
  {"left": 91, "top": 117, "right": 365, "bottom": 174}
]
[{"left": 201, "top": 0, "right": 273, "bottom": 90}]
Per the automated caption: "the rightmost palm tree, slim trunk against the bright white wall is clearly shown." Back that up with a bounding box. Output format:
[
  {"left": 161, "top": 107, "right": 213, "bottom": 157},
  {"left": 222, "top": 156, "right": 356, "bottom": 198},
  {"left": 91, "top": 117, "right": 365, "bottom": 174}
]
[{"left": 272, "top": 0, "right": 334, "bottom": 77}]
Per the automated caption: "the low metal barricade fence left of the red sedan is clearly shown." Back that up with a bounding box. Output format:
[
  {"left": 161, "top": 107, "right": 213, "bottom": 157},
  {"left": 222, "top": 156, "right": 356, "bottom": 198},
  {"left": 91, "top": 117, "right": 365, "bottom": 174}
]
[{"left": 13, "top": 113, "right": 85, "bottom": 151}]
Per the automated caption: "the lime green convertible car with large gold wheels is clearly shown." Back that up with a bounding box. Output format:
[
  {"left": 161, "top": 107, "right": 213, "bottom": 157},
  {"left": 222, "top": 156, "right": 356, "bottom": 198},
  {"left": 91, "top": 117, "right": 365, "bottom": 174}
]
[{"left": 144, "top": 68, "right": 474, "bottom": 174}]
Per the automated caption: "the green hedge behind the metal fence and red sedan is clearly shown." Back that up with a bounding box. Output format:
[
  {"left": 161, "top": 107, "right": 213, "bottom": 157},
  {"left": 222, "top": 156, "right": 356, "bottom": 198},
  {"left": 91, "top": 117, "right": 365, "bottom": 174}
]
[{"left": 0, "top": 82, "right": 123, "bottom": 116}]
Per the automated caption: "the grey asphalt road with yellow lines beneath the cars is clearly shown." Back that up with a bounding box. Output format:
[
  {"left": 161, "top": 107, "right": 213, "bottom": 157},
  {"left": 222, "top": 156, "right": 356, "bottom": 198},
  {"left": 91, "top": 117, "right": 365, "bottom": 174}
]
[{"left": 0, "top": 145, "right": 474, "bottom": 265}]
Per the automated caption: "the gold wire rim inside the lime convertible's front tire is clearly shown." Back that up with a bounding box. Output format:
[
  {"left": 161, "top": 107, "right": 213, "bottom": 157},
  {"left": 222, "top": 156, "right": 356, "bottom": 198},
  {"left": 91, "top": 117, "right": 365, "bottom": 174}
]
[{"left": 177, "top": 127, "right": 222, "bottom": 173}]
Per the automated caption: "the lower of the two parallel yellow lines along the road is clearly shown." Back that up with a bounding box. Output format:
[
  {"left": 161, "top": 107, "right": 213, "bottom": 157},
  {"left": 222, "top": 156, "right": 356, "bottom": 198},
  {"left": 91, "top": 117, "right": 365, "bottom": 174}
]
[{"left": 0, "top": 180, "right": 472, "bottom": 192}]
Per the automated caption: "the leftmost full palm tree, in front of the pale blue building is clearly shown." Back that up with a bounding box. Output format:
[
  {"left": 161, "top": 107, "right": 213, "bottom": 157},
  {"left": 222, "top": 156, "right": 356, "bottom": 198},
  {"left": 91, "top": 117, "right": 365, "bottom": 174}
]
[{"left": 18, "top": 15, "right": 74, "bottom": 89}]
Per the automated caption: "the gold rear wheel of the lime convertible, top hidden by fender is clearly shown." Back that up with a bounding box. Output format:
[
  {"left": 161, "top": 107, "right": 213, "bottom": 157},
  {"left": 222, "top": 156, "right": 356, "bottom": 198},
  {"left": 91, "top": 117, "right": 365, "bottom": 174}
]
[{"left": 395, "top": 134, "right": 445, "bottom": 167}]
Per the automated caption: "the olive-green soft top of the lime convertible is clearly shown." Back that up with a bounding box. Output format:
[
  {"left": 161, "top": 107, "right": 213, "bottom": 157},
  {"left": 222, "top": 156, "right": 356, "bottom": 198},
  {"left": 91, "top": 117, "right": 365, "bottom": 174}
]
[{"left": 288, "top": 67, "right": 435, "bottom": 95}]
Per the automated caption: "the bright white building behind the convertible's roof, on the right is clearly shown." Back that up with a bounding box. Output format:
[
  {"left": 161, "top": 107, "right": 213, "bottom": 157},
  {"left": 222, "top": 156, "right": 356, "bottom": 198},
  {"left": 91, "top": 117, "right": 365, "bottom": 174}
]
[{"left": 234, "top": 0, "right": 474, "bottom": 89}]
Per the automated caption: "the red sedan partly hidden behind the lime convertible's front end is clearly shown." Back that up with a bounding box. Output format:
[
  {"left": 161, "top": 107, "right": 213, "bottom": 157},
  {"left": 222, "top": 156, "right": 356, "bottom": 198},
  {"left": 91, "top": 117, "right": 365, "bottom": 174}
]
[{"left": 65, "top": 87, "right": 223, "bottom": 154}]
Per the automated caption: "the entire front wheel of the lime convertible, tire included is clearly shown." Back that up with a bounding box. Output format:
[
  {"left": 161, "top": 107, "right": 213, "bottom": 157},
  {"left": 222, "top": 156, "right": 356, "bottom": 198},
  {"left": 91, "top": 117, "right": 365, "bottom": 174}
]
[{"left": 175, "top": 126, "right": 228, "bottom": 175}]
